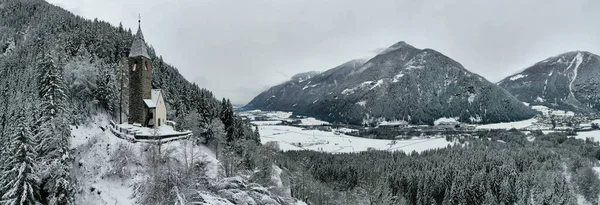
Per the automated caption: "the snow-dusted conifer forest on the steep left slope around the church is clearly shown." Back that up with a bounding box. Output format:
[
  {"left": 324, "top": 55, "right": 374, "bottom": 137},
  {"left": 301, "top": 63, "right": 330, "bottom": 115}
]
[{"left": 0, "top": 0, "right": 259, "bottom": 205}]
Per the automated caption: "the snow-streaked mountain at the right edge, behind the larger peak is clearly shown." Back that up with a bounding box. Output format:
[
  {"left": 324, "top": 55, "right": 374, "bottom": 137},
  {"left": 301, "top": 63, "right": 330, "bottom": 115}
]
[{"left": 498, "top": 51, "right": 600, "bottom": 112}]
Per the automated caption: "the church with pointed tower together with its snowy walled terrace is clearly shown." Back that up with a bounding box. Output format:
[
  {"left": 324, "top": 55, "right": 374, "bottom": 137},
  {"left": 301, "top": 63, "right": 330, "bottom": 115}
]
[{"left": 110, "top": 21, "right": 192, "bottom": 142}]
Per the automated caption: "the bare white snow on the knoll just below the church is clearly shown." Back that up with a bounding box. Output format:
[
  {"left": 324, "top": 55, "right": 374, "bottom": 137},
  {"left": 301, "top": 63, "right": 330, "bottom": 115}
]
[{"left": 71, "top": 115, "right": 218, "bottom": 205}]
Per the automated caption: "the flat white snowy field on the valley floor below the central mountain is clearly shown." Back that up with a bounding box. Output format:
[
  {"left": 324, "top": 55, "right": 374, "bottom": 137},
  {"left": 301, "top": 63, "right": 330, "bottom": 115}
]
[{"left": 259, "top": 125, "right": 452, "bottom": 153}]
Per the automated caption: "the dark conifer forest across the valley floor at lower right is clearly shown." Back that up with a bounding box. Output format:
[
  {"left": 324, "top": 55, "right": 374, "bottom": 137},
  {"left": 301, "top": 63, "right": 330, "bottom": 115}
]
[{"left": 275, "top": 130, "right": 600, "bottom": 205}]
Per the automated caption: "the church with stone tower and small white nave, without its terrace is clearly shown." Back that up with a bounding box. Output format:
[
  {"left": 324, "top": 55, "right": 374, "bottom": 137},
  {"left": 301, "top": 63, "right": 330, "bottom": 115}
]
[{"left": 127, "top": 20, "right": 167, "bottom": 128}]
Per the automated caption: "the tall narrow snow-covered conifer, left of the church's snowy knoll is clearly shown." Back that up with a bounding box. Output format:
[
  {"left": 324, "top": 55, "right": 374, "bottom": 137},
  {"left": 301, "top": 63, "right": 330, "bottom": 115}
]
[{"left": 36, "top": 54, "right": 74, "bottom": 205}]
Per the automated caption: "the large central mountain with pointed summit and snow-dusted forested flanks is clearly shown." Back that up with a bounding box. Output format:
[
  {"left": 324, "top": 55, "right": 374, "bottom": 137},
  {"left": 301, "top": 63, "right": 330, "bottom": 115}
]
[{"left": 246, "top": 42, "right": 535, "bottom": 124}]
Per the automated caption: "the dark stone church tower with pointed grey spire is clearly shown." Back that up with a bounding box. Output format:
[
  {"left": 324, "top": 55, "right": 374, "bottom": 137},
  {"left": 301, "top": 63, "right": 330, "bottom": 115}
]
[{"left": 128, "top": 20, "right": 152, "bottom": 126}]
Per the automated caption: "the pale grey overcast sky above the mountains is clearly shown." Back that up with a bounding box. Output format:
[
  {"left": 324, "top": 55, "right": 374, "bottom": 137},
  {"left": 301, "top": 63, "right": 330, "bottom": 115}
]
[{"left": 49, "top": 0, "right": 600, "bottom": 103}]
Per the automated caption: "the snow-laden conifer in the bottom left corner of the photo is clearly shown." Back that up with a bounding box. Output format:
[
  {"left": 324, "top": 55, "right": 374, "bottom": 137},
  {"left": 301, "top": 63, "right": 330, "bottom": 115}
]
[{"left": 0, "top": 109, "right": 41, "bottom": 205}]
